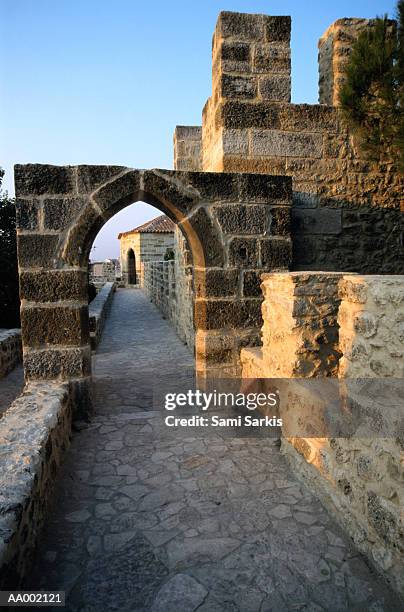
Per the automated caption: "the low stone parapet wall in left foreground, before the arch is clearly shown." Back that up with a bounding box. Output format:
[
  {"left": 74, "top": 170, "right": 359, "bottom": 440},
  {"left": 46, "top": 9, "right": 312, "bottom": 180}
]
[{"left": 0, "top": 382, "right": 71, "bottom": 589}]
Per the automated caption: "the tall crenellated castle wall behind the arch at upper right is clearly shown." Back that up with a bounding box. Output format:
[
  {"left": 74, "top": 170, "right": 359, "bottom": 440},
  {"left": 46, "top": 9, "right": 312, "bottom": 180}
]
[{"left": 181, "top": 12, "right": 404, "bottom": 274}]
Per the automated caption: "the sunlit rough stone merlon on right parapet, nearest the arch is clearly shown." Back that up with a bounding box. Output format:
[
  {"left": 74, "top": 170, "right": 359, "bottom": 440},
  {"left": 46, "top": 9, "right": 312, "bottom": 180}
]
[{"left": 262, "top": 272, "right": 341, "bottom": 378}]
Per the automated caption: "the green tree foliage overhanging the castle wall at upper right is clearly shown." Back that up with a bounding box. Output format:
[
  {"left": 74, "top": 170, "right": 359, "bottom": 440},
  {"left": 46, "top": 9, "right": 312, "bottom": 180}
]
[{"left": 340, "top": 0, "right": 404, "bottom": 170}]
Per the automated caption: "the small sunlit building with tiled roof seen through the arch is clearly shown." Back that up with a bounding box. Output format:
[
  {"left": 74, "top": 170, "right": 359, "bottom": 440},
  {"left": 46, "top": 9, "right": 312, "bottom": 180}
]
[{"left": 118, "top": 215, "right": 175, "bottom": 285}]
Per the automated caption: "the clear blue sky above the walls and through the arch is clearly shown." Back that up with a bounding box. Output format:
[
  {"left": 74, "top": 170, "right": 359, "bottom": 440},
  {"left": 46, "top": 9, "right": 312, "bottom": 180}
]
[{"left": 0, "top": 0, "right": 395, "bottom": 258}]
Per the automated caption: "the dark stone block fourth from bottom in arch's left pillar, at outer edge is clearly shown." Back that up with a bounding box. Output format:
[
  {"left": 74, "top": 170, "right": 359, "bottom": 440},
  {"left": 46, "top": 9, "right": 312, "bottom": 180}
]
[{"left": 17, "top": 234, "right": 59, "bottom": 269}]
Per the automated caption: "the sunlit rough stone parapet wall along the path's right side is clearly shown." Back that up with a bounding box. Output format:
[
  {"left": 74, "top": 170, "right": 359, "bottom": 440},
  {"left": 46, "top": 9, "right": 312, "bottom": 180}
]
[{"left": 241, "top": 272, "right": 404, "bottom": 595}]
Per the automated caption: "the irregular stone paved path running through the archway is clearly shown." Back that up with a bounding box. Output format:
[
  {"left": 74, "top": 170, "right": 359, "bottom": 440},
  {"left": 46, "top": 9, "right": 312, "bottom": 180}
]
[{"left": 31, "top": 290, "right": 400, "bottom": 612}]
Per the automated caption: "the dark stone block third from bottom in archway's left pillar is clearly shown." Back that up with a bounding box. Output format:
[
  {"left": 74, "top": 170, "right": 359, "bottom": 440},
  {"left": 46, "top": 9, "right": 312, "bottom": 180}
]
[{"left": 20, "top": 270, "right": 88, "bottom": 302}]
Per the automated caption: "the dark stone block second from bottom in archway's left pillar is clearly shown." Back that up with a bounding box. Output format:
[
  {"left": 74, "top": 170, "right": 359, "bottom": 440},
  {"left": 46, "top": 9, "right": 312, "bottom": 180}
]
[{"left": 21, "top": 306, "right": 89, "bottom": 347}]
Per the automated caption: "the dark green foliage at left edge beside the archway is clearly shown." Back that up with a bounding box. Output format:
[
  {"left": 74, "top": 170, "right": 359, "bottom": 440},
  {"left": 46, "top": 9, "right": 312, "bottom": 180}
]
[{"left": 0, "top": 168, "right": 20, "bottom": 328}]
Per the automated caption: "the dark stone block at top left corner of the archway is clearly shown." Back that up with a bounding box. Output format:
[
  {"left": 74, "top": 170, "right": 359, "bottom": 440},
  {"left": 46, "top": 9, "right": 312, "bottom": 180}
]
[{"left": 14, "top": 164, "right": 75, "bottom": 197}]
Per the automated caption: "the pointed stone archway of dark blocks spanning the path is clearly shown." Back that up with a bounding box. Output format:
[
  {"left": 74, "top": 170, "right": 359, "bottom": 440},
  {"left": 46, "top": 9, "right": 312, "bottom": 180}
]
[{"left": 15, "top": 164, "right": 292, "bottom": 416}]
